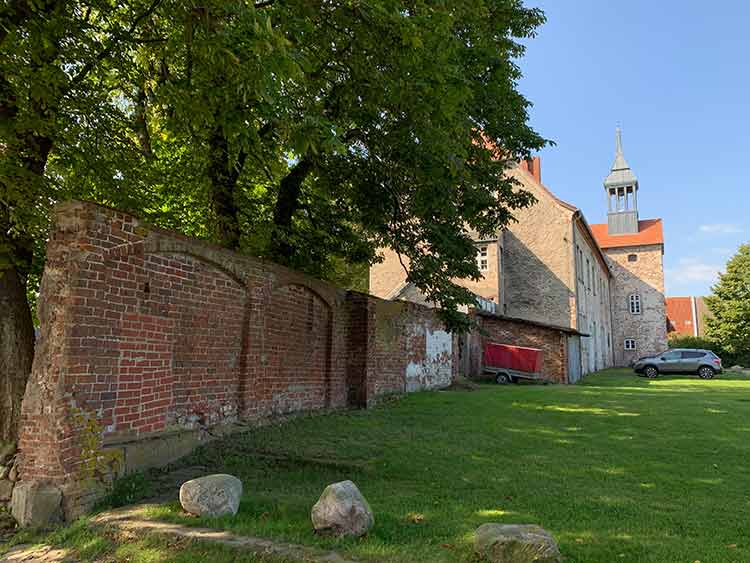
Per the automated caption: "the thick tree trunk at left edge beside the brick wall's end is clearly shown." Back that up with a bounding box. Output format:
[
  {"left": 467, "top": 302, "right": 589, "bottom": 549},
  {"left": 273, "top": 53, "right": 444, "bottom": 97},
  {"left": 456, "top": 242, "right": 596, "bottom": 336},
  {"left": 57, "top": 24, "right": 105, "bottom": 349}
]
[{"left": 0, "top": 266, "right": 34, "bottom": 442}]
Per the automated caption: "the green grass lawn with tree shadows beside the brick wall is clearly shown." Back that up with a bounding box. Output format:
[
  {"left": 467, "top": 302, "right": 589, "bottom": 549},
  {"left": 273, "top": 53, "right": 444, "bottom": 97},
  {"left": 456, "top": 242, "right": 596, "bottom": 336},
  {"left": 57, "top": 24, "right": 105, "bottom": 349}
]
[{"left": 4, "top": 370, "right": 750, "bottom": 563}]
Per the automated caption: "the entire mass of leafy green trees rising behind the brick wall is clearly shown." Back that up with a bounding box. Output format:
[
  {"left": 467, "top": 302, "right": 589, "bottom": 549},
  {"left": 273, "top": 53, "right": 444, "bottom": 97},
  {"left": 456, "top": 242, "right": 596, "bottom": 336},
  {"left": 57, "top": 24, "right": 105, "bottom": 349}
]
[{"left": 0, "top": 0, "right": 545, "bottom": 442}]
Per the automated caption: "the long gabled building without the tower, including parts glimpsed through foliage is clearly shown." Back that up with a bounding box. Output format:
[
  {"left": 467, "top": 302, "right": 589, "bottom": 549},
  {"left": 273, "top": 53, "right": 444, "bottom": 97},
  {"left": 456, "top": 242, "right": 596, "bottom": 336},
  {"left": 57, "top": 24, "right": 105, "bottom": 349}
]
[{"left": 370, "top": 157, "right": 613, "bottom": 382}]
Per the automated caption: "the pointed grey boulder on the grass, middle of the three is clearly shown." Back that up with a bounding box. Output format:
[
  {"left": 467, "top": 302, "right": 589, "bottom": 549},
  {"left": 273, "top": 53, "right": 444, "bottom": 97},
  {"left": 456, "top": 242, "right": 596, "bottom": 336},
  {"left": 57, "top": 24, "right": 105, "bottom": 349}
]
[{"left": 311, "top": 481, "right": 375, "bottom": 537}]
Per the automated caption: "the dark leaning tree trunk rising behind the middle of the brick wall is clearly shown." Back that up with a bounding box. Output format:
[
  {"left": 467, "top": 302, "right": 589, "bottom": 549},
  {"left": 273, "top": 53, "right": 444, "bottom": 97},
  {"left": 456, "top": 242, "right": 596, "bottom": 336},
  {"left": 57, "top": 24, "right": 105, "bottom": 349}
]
[{"left": 271, "top": 156, "right": 314, "bottom": 264}]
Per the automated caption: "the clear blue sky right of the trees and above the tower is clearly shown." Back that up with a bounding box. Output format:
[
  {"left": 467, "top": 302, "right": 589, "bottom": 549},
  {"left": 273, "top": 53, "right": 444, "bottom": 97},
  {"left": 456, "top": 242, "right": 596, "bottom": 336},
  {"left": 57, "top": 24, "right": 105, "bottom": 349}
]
[{"left": 520, "top": 0, "right": 750, "bottom": 295}]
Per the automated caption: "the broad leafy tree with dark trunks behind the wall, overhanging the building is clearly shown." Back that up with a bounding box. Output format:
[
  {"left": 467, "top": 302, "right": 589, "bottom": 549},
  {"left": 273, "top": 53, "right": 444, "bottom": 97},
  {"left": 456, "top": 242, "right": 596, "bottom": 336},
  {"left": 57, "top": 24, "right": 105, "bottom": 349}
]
[{"left": 91, "top": 0, "right": 545, "bottom": 316}]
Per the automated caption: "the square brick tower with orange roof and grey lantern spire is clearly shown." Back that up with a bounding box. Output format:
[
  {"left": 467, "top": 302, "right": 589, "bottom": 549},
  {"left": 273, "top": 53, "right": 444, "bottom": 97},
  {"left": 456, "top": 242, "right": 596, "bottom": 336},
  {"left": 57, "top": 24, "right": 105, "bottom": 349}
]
[{"left": 591, "top": 128, "right": 667, "bottom": 366}]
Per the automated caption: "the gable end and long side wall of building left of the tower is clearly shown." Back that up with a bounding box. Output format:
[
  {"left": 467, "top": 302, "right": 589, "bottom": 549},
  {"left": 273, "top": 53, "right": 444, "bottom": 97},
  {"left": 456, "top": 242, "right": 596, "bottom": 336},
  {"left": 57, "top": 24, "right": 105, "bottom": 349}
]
[{"left": 502, "top": 157, "right": 613, "bottom": 381}]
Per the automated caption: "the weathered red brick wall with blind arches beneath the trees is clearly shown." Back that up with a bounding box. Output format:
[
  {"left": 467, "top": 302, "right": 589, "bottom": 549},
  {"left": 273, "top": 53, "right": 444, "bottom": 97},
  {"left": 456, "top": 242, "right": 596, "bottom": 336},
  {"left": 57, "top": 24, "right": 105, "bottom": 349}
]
[{"left": 14, "top": 202, "right": 457, "bottom": 517}]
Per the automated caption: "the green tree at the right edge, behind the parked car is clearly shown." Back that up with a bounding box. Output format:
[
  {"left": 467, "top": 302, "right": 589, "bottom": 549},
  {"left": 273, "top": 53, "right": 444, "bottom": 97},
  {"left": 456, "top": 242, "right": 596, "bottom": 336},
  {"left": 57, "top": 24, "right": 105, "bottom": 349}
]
[{"left": 706, "top": 244, "right": 750, "bottom": 365}]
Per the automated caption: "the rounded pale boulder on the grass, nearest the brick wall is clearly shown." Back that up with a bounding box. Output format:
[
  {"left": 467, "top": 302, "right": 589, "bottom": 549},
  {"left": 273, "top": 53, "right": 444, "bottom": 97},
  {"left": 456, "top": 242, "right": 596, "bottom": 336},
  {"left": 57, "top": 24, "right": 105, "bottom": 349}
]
[{"left": 180, "top": 473, "right": 242, "bottom": 517}]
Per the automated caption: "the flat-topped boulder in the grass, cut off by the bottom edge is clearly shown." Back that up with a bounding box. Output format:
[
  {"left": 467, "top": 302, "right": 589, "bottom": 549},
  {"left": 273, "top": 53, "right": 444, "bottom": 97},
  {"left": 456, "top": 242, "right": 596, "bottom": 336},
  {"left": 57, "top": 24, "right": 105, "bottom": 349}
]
[{"left": 474, "top": 524, "right": 562, "bottom": 563}]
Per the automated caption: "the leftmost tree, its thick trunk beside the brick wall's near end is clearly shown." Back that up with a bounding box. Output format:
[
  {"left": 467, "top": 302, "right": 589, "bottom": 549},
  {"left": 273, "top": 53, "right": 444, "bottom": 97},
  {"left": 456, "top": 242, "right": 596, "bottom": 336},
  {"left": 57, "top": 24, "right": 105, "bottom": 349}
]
[{"left": 0, "top": 0, "right": 169, "bottom": 446}]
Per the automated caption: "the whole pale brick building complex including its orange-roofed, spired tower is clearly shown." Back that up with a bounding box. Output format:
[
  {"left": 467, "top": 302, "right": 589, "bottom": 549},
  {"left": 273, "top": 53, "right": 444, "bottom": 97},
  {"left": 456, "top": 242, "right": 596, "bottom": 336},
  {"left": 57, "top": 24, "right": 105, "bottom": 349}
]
[{"left": 370, "top": 129, "right": 666, "bottom": 382}]
